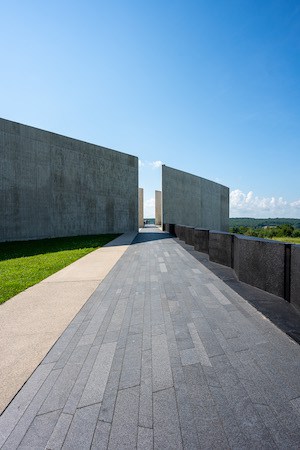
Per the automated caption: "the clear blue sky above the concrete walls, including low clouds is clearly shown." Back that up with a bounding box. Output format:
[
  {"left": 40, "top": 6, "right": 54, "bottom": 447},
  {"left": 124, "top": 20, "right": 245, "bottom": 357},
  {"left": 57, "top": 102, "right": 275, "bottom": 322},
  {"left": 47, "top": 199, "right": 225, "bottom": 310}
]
[{"left": 0, "top": 0, "right": 300, "bottom": 218}]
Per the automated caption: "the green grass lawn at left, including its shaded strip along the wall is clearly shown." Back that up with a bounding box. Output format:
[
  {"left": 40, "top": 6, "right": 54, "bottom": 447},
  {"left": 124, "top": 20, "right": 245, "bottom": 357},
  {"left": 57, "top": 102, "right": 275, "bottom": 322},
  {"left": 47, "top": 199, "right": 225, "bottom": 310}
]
[{"left": 0, "top": 234, "right": 118, "bottom": 303}]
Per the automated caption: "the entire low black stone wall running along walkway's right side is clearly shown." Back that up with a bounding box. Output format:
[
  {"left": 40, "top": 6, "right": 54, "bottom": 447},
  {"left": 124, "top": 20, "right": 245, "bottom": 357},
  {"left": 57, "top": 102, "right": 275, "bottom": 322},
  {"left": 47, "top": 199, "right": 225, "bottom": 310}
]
[{"left": 168, "top": 225, "right": 300, "bottom": 308}]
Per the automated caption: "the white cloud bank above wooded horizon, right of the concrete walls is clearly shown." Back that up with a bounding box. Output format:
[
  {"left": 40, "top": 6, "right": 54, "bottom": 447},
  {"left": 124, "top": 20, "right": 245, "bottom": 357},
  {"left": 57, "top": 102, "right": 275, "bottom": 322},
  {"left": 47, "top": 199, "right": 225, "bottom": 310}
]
[{"left": 230, "top": 189, "right": 300, "bottom": 218}]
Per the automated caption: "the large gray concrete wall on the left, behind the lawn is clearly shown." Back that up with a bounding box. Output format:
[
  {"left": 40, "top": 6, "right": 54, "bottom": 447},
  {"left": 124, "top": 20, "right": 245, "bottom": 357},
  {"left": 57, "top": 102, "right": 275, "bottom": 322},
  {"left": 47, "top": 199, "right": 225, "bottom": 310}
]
[{"left": 0, "top": 119, "right": 138, "bottom": 241}]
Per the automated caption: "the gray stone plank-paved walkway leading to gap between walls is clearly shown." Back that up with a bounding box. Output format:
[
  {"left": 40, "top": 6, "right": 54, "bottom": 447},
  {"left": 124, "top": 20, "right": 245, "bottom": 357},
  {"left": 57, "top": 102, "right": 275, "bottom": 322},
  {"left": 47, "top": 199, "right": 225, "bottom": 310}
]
[{"left": 0, "top": 228, "right": 300, "bottom": 450}]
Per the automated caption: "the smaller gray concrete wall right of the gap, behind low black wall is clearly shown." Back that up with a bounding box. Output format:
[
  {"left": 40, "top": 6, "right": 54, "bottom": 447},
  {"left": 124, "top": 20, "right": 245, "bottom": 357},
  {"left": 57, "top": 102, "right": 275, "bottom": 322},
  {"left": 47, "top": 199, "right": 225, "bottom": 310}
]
[{"left": 162, "top": 165, "right": 229, "bottom": 231}]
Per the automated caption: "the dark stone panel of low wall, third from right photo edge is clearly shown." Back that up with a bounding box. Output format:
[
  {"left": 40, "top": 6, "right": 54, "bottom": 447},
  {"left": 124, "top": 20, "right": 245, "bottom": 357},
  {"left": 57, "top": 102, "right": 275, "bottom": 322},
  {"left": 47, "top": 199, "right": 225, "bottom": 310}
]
[{"left": 208, "top": 231, "right": 234, "bottom": 267}]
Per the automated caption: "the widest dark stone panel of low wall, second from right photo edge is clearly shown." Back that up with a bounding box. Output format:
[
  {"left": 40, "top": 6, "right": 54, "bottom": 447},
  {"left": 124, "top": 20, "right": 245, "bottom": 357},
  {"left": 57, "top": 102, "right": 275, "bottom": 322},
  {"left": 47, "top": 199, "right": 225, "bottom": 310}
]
[{"left": 234, "top": 234, "right": 285, "bottom": 298}]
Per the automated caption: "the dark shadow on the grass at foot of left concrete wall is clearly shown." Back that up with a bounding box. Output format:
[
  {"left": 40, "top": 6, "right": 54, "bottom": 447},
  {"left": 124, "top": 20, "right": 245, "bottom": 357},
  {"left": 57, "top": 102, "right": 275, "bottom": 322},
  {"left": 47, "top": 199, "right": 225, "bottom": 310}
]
[{"left": 0, "top": 234, "right": 120, "bottom": 261}]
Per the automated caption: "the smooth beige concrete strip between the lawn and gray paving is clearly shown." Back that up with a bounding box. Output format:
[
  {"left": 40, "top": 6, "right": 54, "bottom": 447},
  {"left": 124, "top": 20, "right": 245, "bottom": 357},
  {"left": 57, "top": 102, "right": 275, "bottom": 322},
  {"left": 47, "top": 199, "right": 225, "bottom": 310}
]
[{"left": 0, "top": 232, "right": 137, "bottom": 414}]
